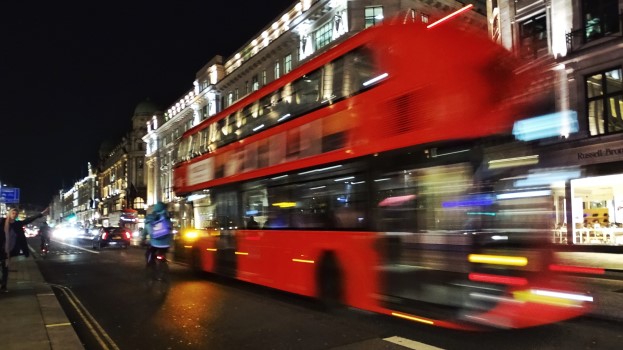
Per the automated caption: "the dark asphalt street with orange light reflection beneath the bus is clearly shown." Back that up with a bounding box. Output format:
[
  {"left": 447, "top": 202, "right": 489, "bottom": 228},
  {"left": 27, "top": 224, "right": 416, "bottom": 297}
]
[{"left": 30, "top": 239, "right": 623, "bottom": 350}]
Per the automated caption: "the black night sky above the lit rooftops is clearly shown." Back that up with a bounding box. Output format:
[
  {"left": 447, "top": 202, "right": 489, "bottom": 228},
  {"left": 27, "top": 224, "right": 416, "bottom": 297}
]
[{"left": 0, "top": 0, "right": 294, "bottom": 206}]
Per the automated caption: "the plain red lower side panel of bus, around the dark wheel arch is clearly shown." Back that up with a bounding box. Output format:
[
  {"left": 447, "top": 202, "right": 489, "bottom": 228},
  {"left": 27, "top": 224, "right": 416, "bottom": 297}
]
[{"left": 237, "top": 230, "right": 379, "bottom": 310}]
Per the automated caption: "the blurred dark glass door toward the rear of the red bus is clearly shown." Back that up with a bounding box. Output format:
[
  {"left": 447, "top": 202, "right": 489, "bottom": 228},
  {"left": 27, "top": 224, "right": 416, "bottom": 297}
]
[{"left": 372, "top": 163, "right": 473, "bottom": 319}]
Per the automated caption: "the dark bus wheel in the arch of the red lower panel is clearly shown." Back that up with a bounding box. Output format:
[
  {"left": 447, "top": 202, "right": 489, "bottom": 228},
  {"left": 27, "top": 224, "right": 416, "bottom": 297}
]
[{"left": 316, "top": 252, "right": 344, "bottom": 310}]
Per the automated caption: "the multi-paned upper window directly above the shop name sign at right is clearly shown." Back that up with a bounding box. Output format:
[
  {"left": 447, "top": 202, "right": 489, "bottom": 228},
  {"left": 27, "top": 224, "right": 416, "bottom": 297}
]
[{"left": 585, "top": 68, "right": 623, "bottom": 136}]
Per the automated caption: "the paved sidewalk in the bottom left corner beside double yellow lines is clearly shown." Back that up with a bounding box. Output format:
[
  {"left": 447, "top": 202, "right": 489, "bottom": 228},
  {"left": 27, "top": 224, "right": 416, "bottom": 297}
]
[{"left": 0, "top": 255, "right": 84, "bottom": 350}]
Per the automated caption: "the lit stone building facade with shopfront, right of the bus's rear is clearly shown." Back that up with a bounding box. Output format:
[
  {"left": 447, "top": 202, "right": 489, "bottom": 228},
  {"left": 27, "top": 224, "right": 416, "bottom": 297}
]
[{"left": 488, "top": 0, "right": 623, "bottom": 244}]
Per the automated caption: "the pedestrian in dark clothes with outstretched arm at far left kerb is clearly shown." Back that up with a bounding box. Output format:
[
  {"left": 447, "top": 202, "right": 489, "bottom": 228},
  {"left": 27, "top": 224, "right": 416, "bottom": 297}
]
[{"left": 0, "top": 208, "right": 50, "bottom": 293}]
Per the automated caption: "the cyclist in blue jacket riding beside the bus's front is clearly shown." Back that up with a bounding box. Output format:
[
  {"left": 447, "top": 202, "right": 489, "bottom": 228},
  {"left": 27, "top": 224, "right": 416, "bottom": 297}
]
[{"left": 142, "top": 202, "right": 173, "bottom": 266}]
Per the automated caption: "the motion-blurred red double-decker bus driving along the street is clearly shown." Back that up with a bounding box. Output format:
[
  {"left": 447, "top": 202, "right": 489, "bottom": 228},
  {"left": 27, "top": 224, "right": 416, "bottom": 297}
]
[{"left": 174, "top": 19, "right": 590, "bottom": 328}]
